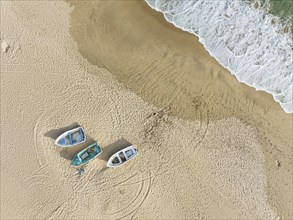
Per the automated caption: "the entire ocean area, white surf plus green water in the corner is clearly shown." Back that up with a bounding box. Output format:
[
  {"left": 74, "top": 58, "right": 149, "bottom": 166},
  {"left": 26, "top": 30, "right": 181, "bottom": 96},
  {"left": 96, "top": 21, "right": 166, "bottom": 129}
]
[{"left": 145, "top": 0, "right": 293, "bottom": 113}]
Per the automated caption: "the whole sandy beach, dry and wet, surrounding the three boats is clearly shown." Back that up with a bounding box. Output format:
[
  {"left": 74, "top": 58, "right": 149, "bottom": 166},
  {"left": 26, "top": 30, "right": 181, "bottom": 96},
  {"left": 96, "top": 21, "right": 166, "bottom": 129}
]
[{"left": 1, "top": 1, "right": 293, "bottom": 219}]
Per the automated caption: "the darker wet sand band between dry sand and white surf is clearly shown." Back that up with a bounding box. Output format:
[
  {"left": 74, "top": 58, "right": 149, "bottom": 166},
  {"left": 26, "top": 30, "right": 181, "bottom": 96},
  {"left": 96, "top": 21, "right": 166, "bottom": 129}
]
[{"left": 71, "top": 1, "right": 292, "bottom": 216}]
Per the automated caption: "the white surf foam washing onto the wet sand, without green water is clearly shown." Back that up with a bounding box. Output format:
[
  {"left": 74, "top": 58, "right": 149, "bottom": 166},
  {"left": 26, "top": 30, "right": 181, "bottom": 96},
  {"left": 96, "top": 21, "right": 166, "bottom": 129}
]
[{"left": 146, "top": 0, "right": 293, "bottom": 113}]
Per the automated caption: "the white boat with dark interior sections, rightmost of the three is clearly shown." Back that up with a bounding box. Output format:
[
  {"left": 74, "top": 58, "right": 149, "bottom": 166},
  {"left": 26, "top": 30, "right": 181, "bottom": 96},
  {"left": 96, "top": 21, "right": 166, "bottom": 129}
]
[{"left": 107, "top": 146, "right": 137, "bottom": 168}]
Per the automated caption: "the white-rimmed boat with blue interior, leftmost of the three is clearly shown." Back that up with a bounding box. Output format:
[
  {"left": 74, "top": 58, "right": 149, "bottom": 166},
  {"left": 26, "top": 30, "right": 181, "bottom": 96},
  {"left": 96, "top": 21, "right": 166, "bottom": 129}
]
[{"left": 55, "top": 127, "right": 85, "bottom": 147}]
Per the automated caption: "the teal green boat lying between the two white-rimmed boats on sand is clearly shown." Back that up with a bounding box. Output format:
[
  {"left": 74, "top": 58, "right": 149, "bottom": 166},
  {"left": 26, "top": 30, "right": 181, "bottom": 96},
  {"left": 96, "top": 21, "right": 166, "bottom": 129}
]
[{"left": 71, "top": 143, "right": 102, "bottom": 166}]
